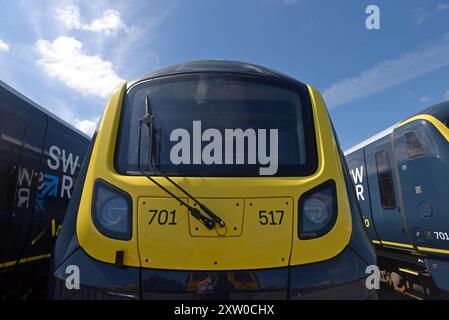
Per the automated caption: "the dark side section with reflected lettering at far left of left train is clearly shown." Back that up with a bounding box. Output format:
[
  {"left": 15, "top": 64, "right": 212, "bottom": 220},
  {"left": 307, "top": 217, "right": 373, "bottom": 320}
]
[{"left": 0, "top": 88, "right": 47, "bottom": 271}]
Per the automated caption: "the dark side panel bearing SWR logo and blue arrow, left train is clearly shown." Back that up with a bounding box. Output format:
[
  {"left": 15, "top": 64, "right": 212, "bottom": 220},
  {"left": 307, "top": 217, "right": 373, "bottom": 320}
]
[{"left": 19, "top": 118, "right": 87, "bottom": 272}]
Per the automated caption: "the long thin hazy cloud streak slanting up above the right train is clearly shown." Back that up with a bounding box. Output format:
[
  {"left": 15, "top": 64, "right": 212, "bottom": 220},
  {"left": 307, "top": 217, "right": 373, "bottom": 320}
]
[{"left": 323, "top": 35, "right": 449, "bottom": 108}]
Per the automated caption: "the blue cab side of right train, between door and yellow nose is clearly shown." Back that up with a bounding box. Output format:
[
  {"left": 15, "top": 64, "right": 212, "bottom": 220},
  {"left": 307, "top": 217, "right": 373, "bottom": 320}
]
[{"left": 394, "top": 120, "right": 449, "bottom": 256}]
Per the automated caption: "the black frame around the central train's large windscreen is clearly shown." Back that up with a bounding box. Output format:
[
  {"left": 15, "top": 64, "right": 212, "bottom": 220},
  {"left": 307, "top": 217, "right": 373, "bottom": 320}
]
[{"left": 114, "top": 71, "right": 319, "bottom": 178}]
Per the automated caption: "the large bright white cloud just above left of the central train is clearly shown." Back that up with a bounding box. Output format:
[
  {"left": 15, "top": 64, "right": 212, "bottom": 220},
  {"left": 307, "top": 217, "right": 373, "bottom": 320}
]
[{"left": 36, "top": 37, "right": 124, "bottom": 98}]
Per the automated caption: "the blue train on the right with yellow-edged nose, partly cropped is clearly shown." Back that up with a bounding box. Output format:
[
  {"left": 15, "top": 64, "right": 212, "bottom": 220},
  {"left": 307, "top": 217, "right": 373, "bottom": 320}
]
[{"left": 345, "top": 101, "right": 449, "bottom": 299}]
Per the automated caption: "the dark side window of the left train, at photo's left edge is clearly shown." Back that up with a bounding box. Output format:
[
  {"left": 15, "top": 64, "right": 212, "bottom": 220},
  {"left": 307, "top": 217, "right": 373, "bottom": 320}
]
[{"left": 0, "top": 115, "right": 26, "bottom": 211}]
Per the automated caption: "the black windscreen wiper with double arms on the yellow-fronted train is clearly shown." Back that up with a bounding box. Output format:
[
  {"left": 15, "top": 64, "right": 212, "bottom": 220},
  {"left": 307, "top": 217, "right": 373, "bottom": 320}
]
[{"left": 138, "top": 95, "right": 226, "bottom": 230}]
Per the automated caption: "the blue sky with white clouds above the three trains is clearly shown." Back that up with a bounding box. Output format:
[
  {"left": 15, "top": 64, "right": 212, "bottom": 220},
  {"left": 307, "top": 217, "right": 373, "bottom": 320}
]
[{"left": 0, "top": 0, "right": 449, "bottom": 149}]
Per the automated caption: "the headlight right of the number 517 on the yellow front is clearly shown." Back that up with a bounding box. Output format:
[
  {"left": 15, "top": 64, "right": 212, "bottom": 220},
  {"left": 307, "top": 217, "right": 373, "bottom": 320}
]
[{"left": 298, "top": 180, "right": 338, "bottom": 239}]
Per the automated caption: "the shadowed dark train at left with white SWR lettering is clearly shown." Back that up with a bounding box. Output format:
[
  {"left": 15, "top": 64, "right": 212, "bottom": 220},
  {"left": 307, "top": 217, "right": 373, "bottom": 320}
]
[{"left": 0, "top": 81, "right": 90, "bottom": 299}]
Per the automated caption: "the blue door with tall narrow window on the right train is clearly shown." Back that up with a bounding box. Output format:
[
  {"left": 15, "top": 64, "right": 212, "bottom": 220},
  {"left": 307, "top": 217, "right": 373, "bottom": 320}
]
[{"left": 365, "top": 135, "right": 413, "bottom": 249}]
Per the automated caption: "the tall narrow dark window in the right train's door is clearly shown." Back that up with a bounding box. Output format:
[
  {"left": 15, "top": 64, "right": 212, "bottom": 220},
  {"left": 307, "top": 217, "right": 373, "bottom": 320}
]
[{"left": 375, "top": 150, "right": 396, "bottom": 209}]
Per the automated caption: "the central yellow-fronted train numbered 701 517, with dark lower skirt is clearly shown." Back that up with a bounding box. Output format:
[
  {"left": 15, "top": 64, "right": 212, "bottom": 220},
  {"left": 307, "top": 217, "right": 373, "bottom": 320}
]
[{"left": 49, "top": 61, "right": 376, "bottom": 299}]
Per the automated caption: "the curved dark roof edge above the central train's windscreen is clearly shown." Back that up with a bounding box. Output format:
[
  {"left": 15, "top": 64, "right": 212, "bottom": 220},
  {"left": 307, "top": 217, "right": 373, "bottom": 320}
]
[{"left": 130, "top": 60, "right": 302, "bottom": 85}]
